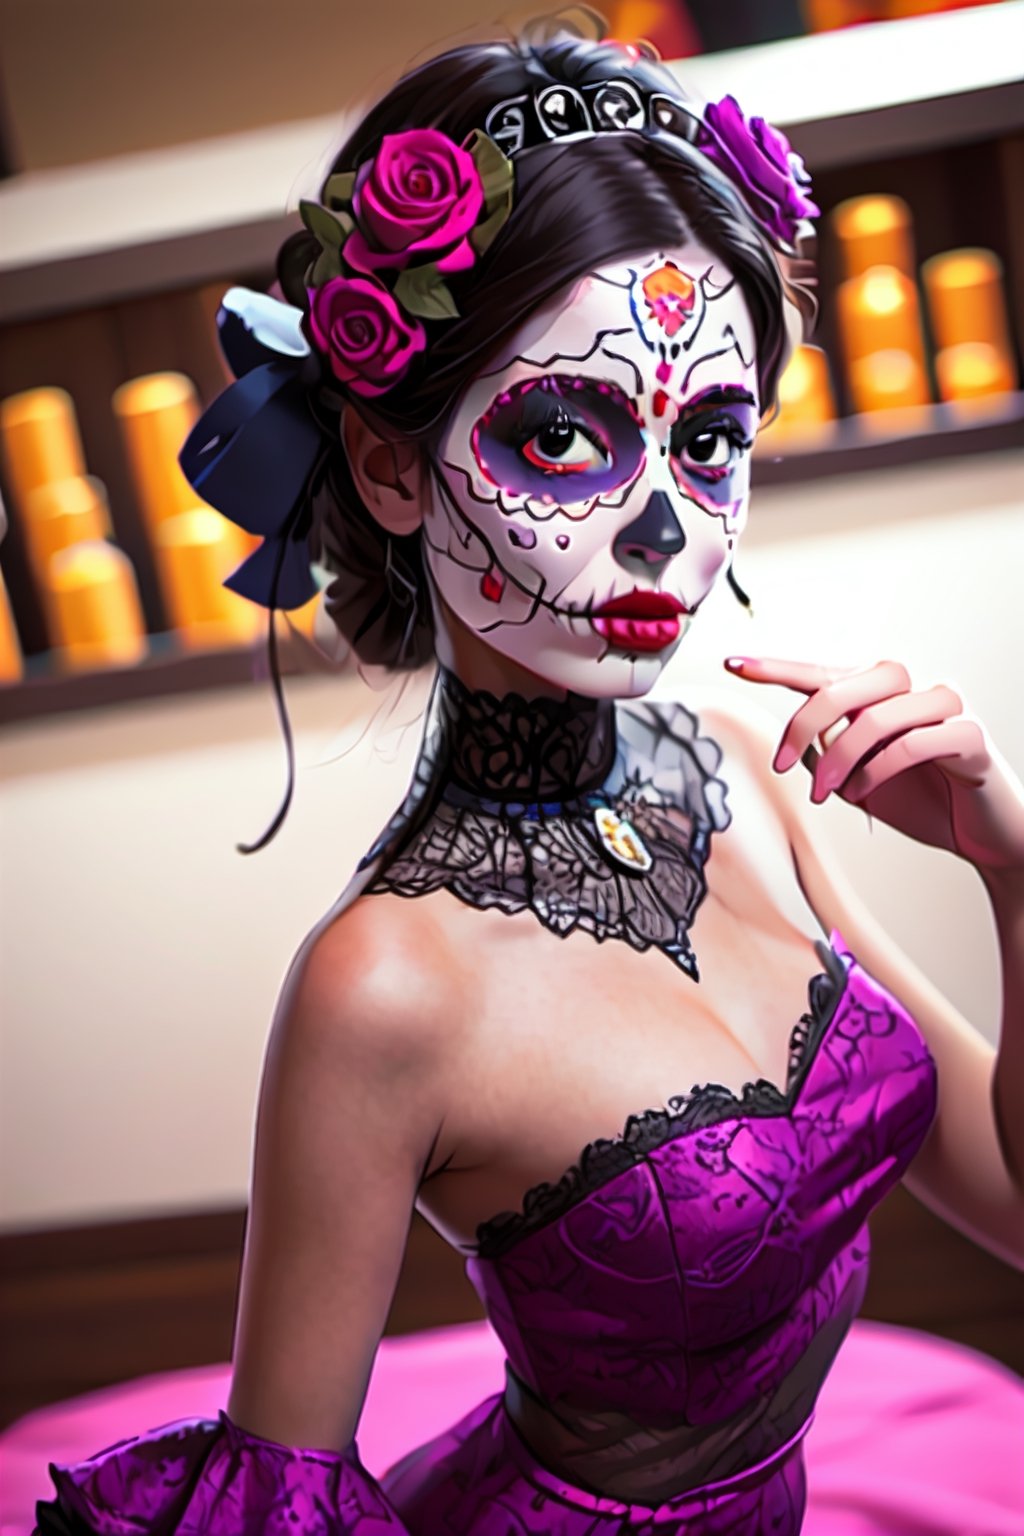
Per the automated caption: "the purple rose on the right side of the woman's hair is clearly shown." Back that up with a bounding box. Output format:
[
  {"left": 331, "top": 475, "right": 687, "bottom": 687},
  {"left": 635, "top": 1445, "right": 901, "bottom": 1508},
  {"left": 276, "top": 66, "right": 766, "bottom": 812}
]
[{"left": 699, "top": 97, "right": 821, "bottom": 246}]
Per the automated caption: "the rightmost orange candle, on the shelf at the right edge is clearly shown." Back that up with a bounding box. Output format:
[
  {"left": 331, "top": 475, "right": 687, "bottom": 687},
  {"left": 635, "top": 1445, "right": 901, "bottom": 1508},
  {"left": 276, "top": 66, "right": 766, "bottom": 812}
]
[{"left": 921, "top": 247, "right": 1016, "bottom": 399}]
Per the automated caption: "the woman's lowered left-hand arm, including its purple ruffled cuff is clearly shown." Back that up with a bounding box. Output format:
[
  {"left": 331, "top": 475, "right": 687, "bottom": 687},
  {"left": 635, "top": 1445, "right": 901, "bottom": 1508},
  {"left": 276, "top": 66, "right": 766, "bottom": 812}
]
[{"left": 37, "top": 900, "right": 459, "bottom": 1536}]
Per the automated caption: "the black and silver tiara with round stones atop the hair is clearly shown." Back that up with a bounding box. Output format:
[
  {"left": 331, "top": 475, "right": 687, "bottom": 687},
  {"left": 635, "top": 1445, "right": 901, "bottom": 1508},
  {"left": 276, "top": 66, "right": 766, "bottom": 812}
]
[{"left": 484, "top": 80, "right": 702, "bottom": 155}]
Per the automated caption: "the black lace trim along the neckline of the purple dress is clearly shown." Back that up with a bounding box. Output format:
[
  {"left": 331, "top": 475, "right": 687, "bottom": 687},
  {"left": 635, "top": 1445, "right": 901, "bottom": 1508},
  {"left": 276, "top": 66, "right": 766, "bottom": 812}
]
[{"left": 476, "top": 945, "right": 847, "bottom": 1260}]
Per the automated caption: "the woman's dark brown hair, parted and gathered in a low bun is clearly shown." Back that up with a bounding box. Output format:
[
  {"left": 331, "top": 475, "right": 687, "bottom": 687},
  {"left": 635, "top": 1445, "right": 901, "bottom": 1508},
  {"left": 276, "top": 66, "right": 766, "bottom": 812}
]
[{"left": 278, "top": 25, "right": 806, "bottom": 668}]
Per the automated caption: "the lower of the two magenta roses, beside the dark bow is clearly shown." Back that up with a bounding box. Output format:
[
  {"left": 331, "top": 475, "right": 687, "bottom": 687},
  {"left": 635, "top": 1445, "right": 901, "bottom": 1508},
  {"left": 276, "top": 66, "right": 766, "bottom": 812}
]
[{"left": 309, "top": 278, "right": 427, "bottom": 396}]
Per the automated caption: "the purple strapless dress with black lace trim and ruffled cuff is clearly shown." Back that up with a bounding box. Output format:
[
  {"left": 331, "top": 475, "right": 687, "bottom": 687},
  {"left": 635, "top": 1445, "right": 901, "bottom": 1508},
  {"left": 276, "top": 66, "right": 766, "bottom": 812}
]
[{"left": 37, "top": 934, "right": 936, "bottom": 1536}]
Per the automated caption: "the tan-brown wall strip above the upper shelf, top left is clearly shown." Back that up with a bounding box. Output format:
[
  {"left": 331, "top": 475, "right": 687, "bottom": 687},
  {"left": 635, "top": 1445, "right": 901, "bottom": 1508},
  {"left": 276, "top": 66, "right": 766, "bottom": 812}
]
[{"left": 0, "top": 0, "right": 540, "bottom": 170}]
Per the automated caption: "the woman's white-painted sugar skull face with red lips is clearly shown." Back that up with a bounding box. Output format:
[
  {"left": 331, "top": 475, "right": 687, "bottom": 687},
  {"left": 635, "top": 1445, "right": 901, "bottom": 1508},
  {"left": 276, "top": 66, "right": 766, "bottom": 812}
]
[{"left": 424, "top": 241, "right": 760, "bottom": 697}]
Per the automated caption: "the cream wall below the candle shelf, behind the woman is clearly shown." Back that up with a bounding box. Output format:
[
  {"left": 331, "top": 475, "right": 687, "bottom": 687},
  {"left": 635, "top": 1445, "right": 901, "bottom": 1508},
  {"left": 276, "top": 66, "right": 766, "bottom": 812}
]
[{"left": 0, "top": 453, "right": 1024, "bottom": 1229}]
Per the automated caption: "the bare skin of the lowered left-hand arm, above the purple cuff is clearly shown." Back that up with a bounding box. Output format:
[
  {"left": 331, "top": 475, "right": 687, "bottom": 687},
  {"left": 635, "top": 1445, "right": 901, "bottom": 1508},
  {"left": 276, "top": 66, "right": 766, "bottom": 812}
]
[{"left": 227, "top": 902, "right": 454, "bottom": 1450}]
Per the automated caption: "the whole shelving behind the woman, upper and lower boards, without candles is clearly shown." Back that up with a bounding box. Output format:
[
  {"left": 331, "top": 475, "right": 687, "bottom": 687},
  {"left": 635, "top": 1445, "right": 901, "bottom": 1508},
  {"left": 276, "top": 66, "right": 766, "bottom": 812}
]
[{"left": 0, "top": 0, "right": 1024, "bottom": 725}]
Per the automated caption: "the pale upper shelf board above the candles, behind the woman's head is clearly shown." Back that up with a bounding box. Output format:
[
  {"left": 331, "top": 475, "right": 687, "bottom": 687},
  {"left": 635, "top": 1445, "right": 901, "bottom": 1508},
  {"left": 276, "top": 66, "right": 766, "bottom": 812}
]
[{"left": 0, "top": 0, "right": 1024, "bottom": 323}]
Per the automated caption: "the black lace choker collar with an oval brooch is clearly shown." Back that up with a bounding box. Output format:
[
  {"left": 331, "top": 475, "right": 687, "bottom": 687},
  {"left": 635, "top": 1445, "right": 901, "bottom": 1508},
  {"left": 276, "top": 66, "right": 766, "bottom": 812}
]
[{"left": 361, "top": 670, "right": 729, "bottom": 980}]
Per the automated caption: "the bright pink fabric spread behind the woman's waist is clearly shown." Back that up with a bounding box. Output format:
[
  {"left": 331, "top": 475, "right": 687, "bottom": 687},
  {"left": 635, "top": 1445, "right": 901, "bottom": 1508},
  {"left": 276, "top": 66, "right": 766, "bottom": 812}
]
[{"left": 0, "top": 1322, "right": 1024, "bottom": 1536}]
